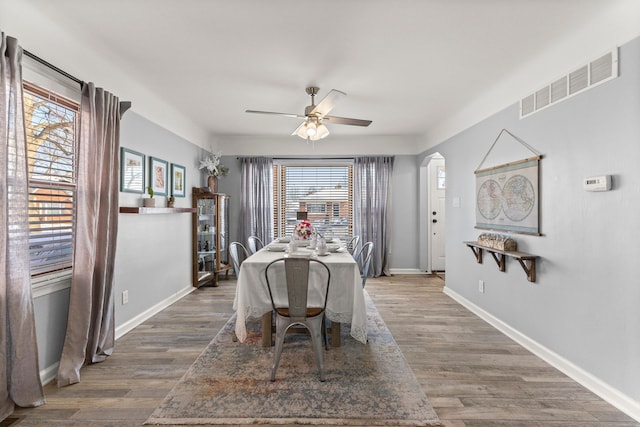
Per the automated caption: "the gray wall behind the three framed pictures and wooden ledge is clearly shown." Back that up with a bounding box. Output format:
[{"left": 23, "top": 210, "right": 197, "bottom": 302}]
[{"left": 115, "top": 112, "right": 204, "bottom": 325}]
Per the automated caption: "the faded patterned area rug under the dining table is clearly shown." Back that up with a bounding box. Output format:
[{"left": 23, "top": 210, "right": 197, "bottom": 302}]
[{"left": 145, "top": 294, "right": 440, "bottom": 426}]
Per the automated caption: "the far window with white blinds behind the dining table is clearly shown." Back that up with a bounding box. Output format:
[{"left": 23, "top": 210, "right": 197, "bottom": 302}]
[{"left": 273, "top": 160, "right": 353, "bottom": 240}]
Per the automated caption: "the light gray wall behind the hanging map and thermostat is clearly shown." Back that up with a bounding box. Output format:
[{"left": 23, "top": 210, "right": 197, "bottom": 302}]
[{"left": 423, "top": 39, "right": 640, "bottom": 405}]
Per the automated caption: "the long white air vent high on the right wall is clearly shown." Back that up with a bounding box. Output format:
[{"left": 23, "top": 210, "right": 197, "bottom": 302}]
[{"left": 520, "top": 48, "right": 618, "bottom": 118}]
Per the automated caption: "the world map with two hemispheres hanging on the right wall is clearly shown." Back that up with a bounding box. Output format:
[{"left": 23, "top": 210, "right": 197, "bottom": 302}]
[{"left": 475, "top": 157, "right": 540, "bottom": 234}]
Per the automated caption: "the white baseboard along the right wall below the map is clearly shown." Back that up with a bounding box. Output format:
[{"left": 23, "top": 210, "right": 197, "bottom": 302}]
[{"left": 444, "top": 286, "right": 640, "bottom": 422}]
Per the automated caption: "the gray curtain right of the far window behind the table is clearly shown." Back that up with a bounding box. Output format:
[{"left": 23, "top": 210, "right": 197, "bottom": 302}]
[{"left": 353, "top": 156, "right": 393, "bottom": 277}]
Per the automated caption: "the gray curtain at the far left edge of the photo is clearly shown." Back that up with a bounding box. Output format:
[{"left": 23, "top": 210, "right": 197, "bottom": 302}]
[{"left": 0, "top": 33, "right": 45, "bottom": 420}]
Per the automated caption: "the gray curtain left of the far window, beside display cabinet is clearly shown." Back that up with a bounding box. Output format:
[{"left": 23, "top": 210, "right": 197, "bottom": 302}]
[{"left": 240, "top": 157, "right": 273, "bottom": 244}]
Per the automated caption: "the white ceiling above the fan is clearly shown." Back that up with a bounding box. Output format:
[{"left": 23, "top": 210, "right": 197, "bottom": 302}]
[{"left": 0, "top": 0, "right": 640, "bottom": 150}]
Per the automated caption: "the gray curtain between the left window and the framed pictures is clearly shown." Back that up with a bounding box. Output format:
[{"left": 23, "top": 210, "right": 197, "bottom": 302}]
[{"left": 58, "top": 83, "right": 120, "bottom": 387}]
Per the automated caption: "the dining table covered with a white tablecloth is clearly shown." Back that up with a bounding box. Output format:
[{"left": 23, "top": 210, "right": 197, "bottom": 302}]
[{"left": 233, "top": 240, "right": 367, "bottom": 347}]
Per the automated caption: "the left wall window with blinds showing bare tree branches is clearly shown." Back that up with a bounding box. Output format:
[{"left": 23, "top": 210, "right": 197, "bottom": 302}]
[{"left": 23, "top": 81, "right": 79, "bottom": 276}]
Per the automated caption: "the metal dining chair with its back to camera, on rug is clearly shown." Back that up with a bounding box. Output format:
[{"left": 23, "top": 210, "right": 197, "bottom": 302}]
[{"left": 264, "top": 257, "right": 331, "bottom": 381}]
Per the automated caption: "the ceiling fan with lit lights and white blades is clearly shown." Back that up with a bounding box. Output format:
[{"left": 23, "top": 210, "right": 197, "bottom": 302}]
[{"left": 246, "top": 86, "right": 371, "bottom": 141}]
